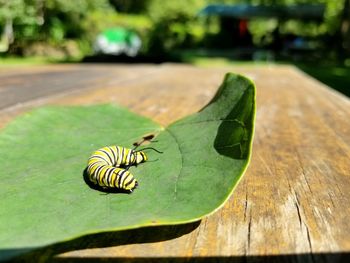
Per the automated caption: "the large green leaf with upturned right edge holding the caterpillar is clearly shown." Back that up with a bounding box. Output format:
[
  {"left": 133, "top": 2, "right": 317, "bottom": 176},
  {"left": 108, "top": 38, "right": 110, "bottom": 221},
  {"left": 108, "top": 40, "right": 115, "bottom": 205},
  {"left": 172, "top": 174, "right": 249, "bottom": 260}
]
[{"left": 0, "top": 74, "right": 255, "bottom": 255}]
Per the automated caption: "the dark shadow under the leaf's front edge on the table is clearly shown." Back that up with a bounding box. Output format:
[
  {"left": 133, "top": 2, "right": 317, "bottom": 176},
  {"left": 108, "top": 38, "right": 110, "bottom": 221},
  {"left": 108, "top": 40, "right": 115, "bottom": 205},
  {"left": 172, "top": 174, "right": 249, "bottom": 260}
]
[{"left": 0, "top": 221, "right": 200, "bottom": 262}]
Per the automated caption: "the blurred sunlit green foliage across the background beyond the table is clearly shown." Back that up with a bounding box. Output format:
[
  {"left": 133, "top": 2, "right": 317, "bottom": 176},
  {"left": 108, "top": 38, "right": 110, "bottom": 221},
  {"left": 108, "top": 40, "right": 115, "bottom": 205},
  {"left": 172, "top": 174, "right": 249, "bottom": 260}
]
[{"left": 0, "top": 0, "right": 346, "bottom": 57}]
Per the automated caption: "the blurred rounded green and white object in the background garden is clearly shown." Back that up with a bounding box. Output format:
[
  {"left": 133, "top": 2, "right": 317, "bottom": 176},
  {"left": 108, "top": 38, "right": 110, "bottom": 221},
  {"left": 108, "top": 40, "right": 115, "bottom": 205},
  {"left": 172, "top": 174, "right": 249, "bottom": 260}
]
[{"left": 94, "top": 27, "right": 142, "bottom": 57}]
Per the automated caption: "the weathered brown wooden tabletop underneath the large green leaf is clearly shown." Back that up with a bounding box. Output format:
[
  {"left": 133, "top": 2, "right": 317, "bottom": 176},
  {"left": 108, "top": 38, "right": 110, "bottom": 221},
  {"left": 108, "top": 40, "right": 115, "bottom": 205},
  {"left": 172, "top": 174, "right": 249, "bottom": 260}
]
[{"left": 0, "top": 64, "right": 350, "bottom": 262}]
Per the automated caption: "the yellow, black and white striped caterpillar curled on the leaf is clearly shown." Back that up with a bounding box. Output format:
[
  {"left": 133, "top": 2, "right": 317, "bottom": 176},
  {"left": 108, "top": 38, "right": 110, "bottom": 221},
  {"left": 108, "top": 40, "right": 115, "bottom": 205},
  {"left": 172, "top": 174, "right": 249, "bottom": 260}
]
[{"left": 87, "top": 146, "right": 147, "bottom": 192}]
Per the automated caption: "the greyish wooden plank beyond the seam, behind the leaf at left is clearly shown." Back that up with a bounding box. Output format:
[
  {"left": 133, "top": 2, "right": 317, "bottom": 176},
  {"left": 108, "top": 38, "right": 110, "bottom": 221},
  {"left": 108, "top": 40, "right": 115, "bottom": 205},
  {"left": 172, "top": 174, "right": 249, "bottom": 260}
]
[{"left": 0, "top": 65, "right": 159, "bottom": 128}]
